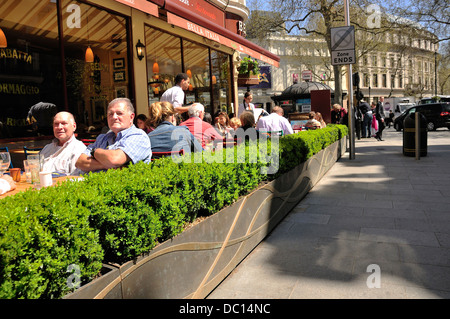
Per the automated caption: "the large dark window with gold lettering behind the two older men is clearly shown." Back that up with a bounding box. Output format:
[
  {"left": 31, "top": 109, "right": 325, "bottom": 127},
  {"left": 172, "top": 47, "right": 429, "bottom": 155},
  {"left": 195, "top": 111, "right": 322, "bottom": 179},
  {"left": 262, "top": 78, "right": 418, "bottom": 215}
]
[{"left": 0, "top": 0, "right": 130, "bottom": 138}]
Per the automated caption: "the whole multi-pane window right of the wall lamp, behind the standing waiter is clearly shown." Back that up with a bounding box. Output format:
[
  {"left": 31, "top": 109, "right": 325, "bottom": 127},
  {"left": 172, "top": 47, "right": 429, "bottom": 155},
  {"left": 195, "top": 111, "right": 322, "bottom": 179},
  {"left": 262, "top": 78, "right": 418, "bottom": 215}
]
[{"left": 145, "top": 25, "right": 232, "bottom": 115}]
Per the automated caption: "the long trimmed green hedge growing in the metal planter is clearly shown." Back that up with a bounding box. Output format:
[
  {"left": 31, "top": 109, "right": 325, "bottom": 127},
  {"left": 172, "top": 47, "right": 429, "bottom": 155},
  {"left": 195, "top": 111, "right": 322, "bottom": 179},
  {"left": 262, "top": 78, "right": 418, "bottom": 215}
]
[{"left": 0, "top": 125, "right": 348, "bottom": 298}]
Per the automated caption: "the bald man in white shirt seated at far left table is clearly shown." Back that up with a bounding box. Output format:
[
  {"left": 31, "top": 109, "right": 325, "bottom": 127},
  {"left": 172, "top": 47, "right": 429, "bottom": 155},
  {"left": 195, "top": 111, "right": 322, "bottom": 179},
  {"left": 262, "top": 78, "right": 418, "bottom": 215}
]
[{"left": 40, "top": 112, "right": 86, "bottom": 175}]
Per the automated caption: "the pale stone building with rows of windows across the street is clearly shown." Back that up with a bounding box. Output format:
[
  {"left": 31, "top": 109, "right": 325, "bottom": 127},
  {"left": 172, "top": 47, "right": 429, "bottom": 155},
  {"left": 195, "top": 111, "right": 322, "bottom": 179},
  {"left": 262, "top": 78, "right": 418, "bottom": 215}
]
[{"left": 248, "top": 19, "right": 439, "bottom": 104}]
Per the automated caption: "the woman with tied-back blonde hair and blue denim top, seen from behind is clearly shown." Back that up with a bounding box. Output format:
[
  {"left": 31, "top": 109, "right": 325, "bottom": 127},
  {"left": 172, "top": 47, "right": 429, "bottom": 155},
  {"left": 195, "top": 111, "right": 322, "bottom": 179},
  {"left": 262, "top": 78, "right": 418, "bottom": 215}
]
[{"left": 146, "top": 102, "right": 203, "bottom": 158}]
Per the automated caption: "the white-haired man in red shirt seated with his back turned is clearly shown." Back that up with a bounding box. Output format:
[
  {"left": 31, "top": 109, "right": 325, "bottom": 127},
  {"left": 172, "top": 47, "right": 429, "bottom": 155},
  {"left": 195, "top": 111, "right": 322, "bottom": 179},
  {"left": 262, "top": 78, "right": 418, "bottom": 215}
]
[{"left": 179, "top": 103, "right": 223, "bottom": 148}]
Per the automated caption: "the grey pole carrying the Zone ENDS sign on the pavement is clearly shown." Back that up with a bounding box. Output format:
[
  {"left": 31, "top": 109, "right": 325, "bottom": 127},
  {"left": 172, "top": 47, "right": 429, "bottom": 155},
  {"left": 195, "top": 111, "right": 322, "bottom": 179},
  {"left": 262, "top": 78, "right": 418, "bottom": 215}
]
[{"left": 331, "top": 0, "right": 355, "bottom": 160}]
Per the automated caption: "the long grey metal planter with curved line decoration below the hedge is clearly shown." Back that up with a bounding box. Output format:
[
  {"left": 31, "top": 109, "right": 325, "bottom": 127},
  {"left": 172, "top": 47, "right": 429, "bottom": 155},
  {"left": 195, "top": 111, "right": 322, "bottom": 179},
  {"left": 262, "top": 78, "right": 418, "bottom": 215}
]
[{"left": 65, "top": 138, "right": 346, "bottom": 299}]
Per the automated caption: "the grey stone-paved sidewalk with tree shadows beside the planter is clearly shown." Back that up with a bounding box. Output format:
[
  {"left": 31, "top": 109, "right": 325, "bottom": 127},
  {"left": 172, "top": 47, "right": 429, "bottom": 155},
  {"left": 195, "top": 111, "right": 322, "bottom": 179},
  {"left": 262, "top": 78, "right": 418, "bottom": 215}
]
[{"left": 208, "top": 128, "right": 450, "bottom": 299}]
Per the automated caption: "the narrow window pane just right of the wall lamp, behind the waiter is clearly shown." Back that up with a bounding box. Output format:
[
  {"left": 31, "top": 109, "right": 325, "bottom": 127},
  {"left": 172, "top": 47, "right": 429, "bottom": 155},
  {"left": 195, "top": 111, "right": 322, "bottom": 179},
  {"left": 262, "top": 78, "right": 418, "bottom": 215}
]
[{"left": 145, "top": 26, "right": 182, "bottom": 105}]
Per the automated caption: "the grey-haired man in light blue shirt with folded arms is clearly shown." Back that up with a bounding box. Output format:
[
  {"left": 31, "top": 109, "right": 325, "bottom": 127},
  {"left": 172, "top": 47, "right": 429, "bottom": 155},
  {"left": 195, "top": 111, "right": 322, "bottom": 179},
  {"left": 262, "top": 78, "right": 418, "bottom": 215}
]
[{"left": 76, "top": 98, "right": 152, "bottom": 172}]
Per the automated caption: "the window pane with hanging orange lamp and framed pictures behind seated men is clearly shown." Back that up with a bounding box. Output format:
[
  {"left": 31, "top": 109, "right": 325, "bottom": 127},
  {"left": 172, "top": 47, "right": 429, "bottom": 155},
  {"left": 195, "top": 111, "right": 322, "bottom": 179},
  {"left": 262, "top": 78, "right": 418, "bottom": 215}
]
[{"left": 62, "top": 0, "right": 131, "bottom": 133}]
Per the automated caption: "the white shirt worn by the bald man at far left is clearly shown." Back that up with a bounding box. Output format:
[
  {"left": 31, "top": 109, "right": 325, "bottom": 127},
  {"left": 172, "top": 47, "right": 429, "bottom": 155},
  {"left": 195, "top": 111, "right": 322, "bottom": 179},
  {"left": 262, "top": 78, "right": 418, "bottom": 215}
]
[{"left": 40, "top": 135, "right": 86, "bottom": 175}]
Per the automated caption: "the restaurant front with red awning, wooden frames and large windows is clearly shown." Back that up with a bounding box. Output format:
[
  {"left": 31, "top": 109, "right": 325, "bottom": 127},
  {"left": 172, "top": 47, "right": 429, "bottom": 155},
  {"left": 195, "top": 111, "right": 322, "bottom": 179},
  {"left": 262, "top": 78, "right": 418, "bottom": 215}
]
[{"left": 0, "top": 0, "right": 279, "bottom": 139}]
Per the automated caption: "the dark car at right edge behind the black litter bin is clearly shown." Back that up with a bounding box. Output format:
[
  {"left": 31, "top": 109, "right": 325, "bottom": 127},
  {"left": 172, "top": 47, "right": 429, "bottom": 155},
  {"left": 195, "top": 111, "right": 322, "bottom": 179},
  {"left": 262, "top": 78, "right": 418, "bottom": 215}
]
[{"left": 394, "top": 103, "right": 450, "bottom": 131}]
